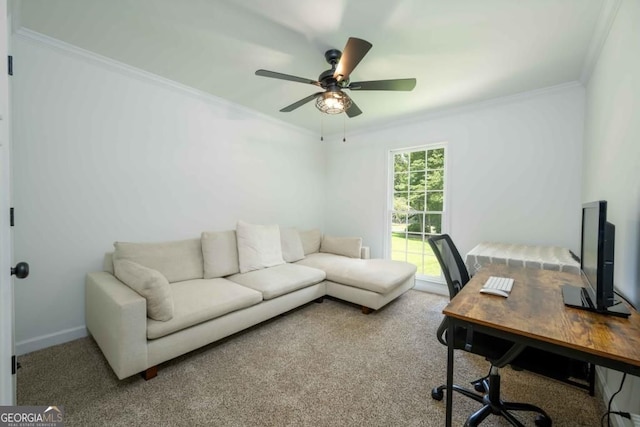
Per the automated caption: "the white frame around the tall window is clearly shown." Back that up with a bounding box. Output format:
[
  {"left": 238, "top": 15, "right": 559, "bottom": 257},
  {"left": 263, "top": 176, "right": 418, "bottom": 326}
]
[{"left": 384, "top": 142, "right": 451, "bottom": 284}]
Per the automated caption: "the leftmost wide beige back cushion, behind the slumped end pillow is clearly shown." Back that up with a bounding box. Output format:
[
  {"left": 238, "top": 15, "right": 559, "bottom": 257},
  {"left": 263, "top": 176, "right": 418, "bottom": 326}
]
[{"left": 113, "top": 239, "right": 204, "bottom": 283}]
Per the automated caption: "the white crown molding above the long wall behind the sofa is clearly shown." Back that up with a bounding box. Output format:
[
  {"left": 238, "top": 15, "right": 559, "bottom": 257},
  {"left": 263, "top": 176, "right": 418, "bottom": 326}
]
[{"left": 13, "top": 27, "right": 316, "bottom": 139}]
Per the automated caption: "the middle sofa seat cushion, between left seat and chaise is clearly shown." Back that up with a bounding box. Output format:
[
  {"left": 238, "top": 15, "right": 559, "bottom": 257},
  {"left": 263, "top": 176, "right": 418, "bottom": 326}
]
[{"left": 228, "top": 264, "right": 326, "bottom": 300}]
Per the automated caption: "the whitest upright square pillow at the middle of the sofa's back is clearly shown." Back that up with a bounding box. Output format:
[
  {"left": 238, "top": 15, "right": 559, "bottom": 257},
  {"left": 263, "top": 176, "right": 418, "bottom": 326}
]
[{"left": 236, "top": 221, "right": 284, "bottom": 273}]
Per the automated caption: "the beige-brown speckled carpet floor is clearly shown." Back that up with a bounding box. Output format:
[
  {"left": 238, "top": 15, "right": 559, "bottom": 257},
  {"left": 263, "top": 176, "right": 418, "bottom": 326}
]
[{"left": 17, "top": 290, "right": 605, "bottom": 427}]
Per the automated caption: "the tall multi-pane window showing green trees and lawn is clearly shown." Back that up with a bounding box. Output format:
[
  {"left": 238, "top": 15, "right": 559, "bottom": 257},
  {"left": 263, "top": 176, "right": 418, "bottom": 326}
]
[{"left": 389, "top": 144, "right": 447, "bottom": 280}]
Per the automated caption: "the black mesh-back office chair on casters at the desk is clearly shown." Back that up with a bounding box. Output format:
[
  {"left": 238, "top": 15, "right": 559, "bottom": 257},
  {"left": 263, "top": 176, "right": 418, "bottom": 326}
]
[{"left": 429, "top": 234, "right": 551, "bottom": 427}]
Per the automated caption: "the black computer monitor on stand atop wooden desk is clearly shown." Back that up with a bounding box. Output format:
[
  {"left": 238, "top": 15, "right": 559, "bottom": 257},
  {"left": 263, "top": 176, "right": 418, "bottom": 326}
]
[{"left": 562, "top": 200, "right": 629, "bottom": 316}]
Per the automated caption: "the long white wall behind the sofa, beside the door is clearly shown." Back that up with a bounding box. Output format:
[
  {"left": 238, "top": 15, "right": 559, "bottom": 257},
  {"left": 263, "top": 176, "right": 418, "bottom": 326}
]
[{"left": 12, "top": 36, "right": 325, "bottom": 353}]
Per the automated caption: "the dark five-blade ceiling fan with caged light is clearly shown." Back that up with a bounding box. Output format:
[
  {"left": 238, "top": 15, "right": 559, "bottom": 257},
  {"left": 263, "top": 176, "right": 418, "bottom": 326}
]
[{"left": 256, "top": 37, "right": 416, "bottom": 117}]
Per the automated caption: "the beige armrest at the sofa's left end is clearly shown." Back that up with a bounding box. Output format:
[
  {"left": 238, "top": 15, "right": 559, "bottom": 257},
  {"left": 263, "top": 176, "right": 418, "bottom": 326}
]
[{"left": 85, "top": 271, "right": 148, "bottom": 379}]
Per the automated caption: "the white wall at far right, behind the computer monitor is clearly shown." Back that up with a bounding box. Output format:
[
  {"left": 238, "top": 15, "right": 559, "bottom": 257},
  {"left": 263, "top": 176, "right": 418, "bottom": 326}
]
[{"left": 582, "top": 0, "right": 640, "bottom": 422}]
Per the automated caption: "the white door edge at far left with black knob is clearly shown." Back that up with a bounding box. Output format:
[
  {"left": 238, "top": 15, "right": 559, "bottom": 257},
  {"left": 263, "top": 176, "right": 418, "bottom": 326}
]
[{"left": 0, "top": 0, "right": 16, "bottom": 405}]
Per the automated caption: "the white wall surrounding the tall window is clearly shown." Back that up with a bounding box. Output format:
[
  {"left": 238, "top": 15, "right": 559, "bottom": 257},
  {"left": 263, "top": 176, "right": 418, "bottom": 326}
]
[{"left": 325, "top": 84, "right": 584, "bottom": 256}]
